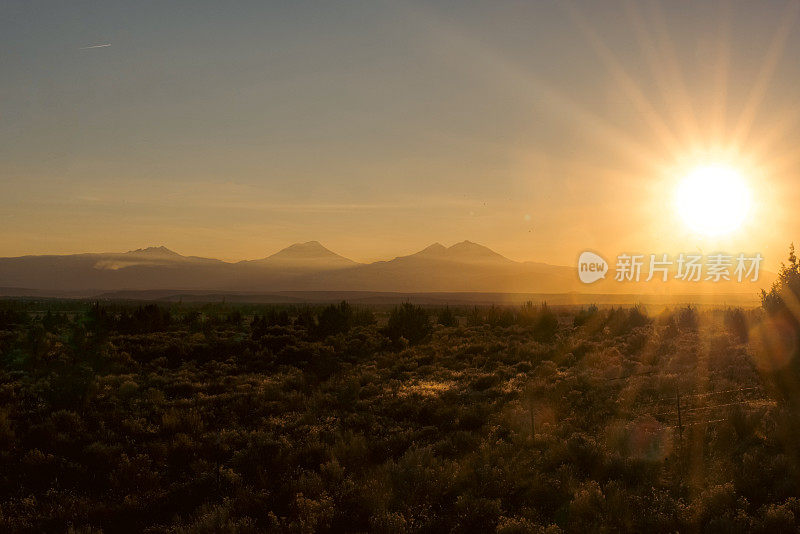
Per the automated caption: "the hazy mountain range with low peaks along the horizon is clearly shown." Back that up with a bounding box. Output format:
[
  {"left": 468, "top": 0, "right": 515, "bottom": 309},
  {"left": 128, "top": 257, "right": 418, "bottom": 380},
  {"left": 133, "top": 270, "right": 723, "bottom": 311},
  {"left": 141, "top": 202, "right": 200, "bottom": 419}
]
[{"left": 0, "top": 241, "right": 774, "bottom": 296}]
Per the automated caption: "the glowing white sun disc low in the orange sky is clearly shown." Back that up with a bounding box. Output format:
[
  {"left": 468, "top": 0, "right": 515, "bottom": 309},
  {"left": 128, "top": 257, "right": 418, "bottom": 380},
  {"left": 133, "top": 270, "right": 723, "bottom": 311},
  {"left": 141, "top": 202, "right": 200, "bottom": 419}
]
[{"left": 675, "top": 164, "right": 752, "bottom": 237}]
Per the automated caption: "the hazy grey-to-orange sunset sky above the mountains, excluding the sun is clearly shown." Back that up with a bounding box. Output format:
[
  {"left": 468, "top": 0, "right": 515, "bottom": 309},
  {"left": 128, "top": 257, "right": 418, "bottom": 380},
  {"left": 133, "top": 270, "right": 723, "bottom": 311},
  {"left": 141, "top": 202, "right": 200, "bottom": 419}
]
[{"left": 0, "top": 0, "right": 800, "bottom": 266}]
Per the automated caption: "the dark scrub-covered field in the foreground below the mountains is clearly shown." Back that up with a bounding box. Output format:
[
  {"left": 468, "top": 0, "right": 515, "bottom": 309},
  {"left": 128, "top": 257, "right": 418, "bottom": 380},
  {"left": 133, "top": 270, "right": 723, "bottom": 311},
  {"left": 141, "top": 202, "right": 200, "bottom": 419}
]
[{"left": 0, "top": 258, "right": 800, "bottom": 533}]
